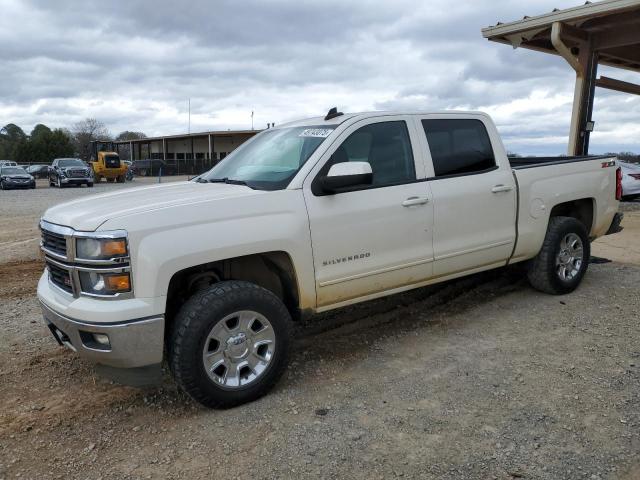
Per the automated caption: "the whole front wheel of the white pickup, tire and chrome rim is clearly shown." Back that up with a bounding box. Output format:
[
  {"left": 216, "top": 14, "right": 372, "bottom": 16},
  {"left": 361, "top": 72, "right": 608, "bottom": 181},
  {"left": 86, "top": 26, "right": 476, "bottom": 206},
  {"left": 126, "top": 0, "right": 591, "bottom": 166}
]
[{"left": 169, "top": 281, "right": 291, "bottom": 408}]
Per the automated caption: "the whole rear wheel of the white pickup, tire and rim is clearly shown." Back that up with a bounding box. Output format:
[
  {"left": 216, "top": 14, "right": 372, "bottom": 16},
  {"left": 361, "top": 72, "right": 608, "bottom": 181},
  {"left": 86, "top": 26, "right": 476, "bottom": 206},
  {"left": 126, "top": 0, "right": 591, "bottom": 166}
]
[{"left": 528, "top": 217, "right": 591, "bottom": 295}]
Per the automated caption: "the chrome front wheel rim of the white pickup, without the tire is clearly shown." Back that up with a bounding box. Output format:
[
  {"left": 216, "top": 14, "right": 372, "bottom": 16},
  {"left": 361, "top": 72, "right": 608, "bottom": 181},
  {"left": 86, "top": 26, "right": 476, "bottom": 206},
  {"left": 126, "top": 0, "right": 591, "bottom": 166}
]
[{"left": 202, "top": 310, "right": 276, "bottom": 390}]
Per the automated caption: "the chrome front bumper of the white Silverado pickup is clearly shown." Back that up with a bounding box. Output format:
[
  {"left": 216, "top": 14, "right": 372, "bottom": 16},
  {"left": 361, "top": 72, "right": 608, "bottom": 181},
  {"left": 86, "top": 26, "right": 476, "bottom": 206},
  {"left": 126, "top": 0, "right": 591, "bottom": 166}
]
[{"left": 40, "top": 302, "right": 164, "bottom": 368}]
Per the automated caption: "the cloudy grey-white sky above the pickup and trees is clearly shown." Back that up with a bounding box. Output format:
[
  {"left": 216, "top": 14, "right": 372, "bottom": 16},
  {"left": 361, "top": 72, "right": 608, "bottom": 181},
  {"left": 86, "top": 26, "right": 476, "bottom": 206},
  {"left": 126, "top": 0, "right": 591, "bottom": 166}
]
[{"left": 0, "top": 0, "right": 640, "bottom": 154}]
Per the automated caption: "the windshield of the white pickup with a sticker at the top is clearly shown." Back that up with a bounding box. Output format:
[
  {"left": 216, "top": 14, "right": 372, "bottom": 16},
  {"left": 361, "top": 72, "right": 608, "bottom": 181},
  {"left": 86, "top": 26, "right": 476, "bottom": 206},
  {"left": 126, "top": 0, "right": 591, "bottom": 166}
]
[{"left": 198, "top": 125, "right": 336, "bottom": 190}]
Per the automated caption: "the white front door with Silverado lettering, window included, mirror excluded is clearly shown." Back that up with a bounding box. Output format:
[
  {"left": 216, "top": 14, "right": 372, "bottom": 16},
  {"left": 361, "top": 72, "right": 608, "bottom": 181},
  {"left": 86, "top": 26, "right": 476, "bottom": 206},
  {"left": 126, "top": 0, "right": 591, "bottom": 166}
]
[{"left": 303, "top": 116, "right": 433, "bottom": 309}]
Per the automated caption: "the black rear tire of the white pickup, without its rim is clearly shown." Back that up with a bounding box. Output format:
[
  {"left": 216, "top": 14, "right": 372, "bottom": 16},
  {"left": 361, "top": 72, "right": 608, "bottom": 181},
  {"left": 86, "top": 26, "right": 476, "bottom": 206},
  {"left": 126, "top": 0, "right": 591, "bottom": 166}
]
[{"left": 527, "top": 217, "right": 591, "bottom": 295}]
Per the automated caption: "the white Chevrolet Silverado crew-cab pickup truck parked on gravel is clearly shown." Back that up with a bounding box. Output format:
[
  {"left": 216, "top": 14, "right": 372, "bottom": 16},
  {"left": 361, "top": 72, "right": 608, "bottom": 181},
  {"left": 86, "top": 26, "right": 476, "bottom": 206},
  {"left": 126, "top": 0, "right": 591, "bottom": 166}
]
[{"left": 38, "top": 109, "right": 621, "bottom": 407}]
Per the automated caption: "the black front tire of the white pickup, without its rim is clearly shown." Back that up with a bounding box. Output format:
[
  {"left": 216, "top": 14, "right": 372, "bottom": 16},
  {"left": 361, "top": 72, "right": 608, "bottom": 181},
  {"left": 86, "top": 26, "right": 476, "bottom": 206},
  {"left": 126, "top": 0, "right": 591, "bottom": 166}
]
[{"left": 168, "top": 281, "right": 291, "bottom": 408}]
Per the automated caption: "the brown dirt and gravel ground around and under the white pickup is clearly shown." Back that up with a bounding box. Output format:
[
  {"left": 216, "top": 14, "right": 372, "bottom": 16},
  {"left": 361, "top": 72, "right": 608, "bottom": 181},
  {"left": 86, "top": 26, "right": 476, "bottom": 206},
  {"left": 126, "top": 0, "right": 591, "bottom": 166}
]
[{"left": 0, "top": 182, "right": 640, "bottom": 480}]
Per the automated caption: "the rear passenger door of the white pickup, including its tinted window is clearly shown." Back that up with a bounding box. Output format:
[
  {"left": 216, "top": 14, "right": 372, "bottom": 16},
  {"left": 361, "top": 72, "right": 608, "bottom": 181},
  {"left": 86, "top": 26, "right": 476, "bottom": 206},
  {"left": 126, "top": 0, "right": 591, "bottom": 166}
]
[{"left": 420, "top": 115, "right": 517, "bottom": 277}]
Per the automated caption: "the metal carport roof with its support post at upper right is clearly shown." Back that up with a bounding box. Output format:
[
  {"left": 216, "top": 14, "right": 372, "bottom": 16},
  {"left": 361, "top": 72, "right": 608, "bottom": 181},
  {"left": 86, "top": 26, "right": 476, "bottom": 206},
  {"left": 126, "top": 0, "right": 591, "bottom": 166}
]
[{"left": 482, "top": 0, "right": 640, "bottom": 155}]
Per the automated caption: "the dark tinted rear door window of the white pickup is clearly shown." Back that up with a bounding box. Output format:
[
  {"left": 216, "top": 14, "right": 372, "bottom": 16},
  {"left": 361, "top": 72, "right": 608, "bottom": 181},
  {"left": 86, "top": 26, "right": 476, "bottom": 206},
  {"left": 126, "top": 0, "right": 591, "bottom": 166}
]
[{"left": 422, "top": 120, "right": 496, "bottom": 177}]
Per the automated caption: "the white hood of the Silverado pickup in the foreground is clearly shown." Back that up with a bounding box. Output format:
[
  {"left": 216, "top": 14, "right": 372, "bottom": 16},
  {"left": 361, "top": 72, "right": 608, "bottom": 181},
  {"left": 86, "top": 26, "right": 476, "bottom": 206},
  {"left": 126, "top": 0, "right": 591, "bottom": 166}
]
[{"left": 42, "top": 182, "right": 265, "bottom": 231}]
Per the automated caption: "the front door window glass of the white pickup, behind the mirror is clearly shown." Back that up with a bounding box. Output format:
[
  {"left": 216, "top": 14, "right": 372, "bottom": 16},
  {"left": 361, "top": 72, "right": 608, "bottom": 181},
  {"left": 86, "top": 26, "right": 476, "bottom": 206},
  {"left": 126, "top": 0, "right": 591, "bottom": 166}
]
[{"left": 327, "top": 121, "right": 416, "bottom": 187}]
